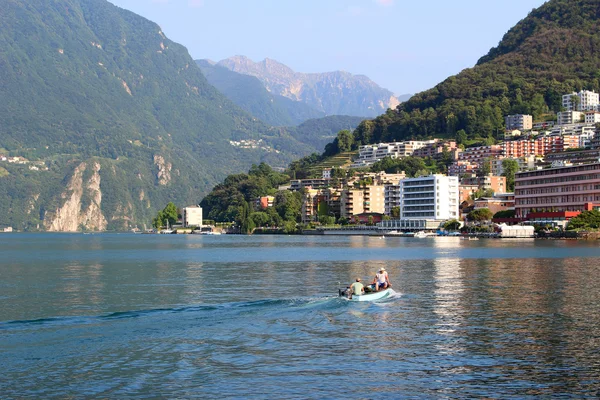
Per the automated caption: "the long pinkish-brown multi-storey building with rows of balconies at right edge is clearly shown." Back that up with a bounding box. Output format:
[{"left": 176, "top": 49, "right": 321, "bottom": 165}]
[{"left": 515, "top": 163, "right": 600, "bottom": 218}]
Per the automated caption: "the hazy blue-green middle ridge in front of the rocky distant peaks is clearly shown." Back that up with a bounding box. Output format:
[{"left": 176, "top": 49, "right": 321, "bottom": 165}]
[{"left": 196, "top": 60, "right": 325, "bottom": 126}]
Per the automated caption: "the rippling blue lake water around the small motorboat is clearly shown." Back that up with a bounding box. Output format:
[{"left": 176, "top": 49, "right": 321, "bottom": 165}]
[{"left": 0, "top": 234, "right": 600, "bottom": 399}]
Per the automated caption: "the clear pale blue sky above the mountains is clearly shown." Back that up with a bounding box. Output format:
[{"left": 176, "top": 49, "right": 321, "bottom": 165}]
[{"left": 110, "top": 0, "right": 544, "bottom": 95}]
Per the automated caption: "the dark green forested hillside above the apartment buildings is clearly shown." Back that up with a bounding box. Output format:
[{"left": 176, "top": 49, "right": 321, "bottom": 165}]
[{"left": 344, "top": 0, "right": 600, "bottom": 146}]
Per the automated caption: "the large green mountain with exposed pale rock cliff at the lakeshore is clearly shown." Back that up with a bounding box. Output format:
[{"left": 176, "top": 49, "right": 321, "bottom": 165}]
[{"left": 0, "top": 0, "right": 313, "bottom": 231}]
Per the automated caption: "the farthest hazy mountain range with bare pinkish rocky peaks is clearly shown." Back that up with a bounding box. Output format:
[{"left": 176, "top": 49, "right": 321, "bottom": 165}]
[{"left": 217, "top": 56, "right": 399, "bottom": 117}]
